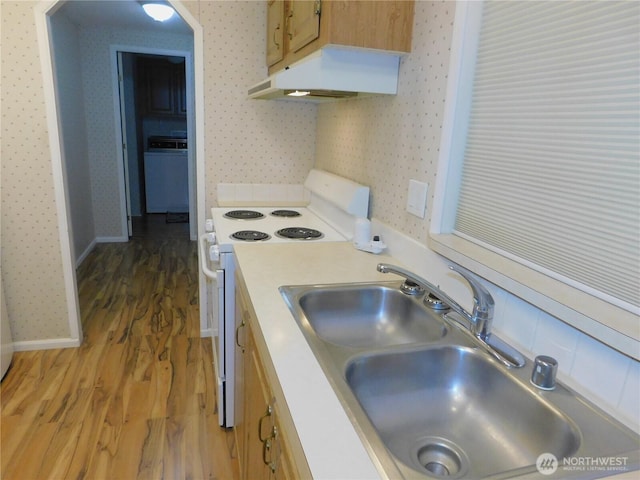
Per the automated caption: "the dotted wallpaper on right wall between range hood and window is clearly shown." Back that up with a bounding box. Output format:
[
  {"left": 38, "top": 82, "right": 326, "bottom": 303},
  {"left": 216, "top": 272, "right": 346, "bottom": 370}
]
[{"left": 316, "top": 1, "right": 455, "bottom": 244}]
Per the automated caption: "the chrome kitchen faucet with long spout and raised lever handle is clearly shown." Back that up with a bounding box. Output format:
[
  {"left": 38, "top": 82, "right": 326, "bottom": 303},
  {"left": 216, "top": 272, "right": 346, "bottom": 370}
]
[{"left": 377, "top": 263, "right": 525, "bottom": 367}]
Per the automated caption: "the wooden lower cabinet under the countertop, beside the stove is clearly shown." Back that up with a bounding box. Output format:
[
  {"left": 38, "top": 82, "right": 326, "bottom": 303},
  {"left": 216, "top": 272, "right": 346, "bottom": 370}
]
[{"left": 235, "top": 280, "right": 308, "bottom": 480}]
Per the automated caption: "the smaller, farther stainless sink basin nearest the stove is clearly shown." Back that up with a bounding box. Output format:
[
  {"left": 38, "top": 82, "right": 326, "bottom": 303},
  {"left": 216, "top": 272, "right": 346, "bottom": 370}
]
[{"left": 281, "top": 285, "right": 447, "bottom": 348}]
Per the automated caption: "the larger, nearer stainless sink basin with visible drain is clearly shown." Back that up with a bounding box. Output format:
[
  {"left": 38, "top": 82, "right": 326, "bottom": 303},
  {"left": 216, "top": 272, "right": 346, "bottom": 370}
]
[{"left": 346, "top": 346, "right": 580, "bottom": 478}]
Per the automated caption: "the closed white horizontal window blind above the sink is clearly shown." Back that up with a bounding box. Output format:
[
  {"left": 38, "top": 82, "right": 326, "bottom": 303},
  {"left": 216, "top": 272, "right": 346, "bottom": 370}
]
[{"left": 453, "top": 1, "right": 640, "bottom": 311}]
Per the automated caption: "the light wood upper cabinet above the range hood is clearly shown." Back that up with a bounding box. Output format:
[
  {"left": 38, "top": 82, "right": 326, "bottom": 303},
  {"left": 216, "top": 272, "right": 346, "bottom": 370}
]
[{"left": 267, "top": 0, "right": 414, "bottom": 74}]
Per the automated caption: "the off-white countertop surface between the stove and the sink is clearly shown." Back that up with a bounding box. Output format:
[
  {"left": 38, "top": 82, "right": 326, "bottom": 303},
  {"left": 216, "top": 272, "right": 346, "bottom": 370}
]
[{"left": 235, "top": 242, "right": 397, "bottom": 480}]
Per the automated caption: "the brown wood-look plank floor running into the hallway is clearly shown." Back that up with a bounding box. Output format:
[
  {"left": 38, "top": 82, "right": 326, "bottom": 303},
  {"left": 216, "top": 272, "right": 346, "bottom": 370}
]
[{"left": 0, "top": 231, "right": 238, "bottom": 480}]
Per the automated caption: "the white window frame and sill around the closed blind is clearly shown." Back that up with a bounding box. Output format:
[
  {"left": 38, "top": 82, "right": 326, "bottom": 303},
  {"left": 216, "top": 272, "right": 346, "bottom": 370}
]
[{"left": 429, "top": 1, "right": 640, "bottom": 359}]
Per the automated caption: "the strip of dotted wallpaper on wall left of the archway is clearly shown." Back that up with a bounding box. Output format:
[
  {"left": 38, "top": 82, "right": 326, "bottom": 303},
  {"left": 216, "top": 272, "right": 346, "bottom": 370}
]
[{"left": 0, "top": 1, "right": 69, "bottom": 340}]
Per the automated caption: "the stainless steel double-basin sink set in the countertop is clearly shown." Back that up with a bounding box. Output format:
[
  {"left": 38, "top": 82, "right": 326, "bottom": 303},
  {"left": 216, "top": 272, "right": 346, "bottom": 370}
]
[{"left": 280, "top": 282, "right": 640, "bottom": 479}]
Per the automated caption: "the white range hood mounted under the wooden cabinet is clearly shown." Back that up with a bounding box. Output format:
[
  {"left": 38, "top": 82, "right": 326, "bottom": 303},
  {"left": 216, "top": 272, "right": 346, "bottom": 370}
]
[{"left": 249, "top": 47, "right": 400, "bottom": 102}]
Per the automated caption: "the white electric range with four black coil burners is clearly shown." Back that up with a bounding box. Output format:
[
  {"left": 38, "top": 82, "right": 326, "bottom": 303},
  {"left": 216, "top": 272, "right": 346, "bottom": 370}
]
[{"left": 200, "top": 170, "right": 369, "bottom": 427}]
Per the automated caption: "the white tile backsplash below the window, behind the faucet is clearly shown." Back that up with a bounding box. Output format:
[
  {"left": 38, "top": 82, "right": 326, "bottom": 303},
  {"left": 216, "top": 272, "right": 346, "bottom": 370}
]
[{"left": 372, "top": 218, "right": 640, "bottom": 433}]
